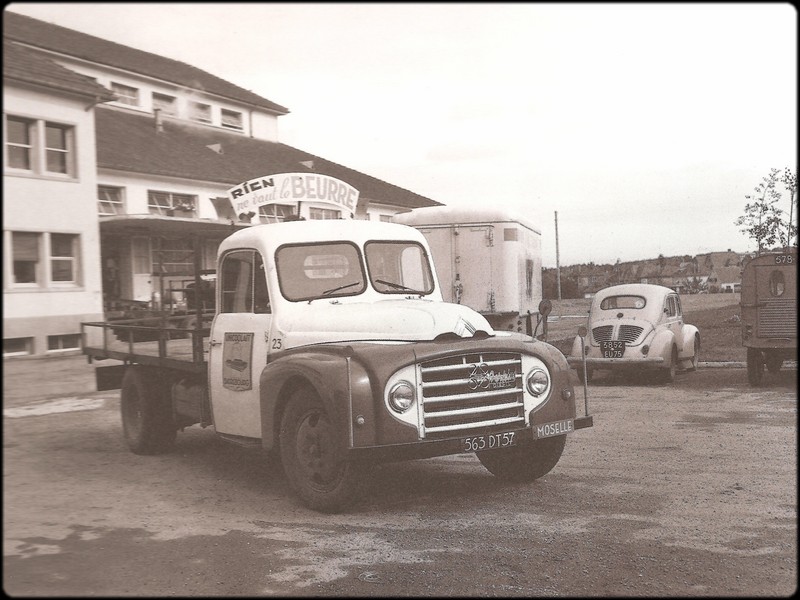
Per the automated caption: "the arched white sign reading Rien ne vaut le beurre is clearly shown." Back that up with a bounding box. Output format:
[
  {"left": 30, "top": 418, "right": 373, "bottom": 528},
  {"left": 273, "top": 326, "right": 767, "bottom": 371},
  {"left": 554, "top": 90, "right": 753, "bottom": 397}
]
[{"left": 228, "top": 173, "right": 358, "bottom": 216}]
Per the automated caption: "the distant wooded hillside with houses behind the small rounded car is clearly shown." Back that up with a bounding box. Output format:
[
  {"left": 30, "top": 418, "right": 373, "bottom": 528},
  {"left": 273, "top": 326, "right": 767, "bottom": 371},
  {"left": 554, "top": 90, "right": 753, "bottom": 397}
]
[{"left": 542, "top": 250, "right": 752, "bottom": 299}]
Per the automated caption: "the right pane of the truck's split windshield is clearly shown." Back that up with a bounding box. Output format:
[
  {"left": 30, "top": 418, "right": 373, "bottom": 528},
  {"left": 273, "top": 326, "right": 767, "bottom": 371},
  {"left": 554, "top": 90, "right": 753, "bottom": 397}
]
[{"left": 365, "top": 241, "right": 433, "bottom": 294}]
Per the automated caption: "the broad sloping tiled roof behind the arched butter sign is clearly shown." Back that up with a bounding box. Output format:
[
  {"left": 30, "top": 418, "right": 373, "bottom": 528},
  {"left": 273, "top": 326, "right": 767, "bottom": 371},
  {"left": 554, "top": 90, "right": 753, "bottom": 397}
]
[{"left": 95, "top": 107, "right": 439, "bottom": 208}]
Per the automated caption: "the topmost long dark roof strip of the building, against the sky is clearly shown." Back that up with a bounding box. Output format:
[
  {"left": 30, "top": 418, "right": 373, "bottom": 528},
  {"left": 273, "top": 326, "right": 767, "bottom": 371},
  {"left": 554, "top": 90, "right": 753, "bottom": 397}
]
[{"left": 3, "top": 8, "right": 289, "bottom": 114}]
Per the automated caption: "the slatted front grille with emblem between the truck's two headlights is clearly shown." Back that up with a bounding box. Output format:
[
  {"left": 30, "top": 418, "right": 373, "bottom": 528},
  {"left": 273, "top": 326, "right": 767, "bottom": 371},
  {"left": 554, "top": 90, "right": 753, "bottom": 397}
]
[{"left": 420, "top": 352, "right": 525, "bottom": 439}]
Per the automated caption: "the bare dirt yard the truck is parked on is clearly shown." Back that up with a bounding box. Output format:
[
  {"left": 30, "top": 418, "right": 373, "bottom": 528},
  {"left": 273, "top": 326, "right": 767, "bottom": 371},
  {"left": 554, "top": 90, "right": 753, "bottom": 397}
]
[{"left": 3, "top": 369, "right": 797, "bottom": 596}]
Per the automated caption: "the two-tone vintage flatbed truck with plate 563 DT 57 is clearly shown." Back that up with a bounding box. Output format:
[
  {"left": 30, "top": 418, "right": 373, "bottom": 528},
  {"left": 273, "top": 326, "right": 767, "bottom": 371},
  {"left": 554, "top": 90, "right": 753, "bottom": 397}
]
[{"left": 82, "top": 220, "right": 592, "bottom": 512}]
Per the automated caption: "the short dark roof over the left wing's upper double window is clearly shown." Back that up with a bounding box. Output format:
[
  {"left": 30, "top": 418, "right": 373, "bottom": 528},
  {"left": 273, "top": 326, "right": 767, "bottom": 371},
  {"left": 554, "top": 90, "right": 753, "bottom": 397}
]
[{"left": 3, "top": 39, "right": 116, "bottom": 102}]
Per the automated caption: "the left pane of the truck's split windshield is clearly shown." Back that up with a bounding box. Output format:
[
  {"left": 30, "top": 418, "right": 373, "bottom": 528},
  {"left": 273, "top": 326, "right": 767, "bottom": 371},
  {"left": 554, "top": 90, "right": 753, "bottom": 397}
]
[{"left": 275, "top": 242, "right": 367, "bottom": 302}]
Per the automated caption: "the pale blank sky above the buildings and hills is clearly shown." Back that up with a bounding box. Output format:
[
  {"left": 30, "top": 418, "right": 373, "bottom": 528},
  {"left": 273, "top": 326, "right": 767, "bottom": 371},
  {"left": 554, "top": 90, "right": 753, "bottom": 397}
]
[{"left": 6, "top": 2, "right": 798, "bottom": 267}]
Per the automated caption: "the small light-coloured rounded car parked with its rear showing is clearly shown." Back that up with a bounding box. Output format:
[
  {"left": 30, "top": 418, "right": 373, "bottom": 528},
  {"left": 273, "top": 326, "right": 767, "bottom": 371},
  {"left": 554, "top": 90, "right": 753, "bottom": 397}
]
[{"left": 567, "top": 283, "right": 700, "bottom": 382}]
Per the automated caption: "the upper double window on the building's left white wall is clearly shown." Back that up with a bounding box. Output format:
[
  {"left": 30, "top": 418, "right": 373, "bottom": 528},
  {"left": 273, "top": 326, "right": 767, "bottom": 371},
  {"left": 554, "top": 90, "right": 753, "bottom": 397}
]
[{"left": 5, "top": 116, "right": 75, "bottom": 177}]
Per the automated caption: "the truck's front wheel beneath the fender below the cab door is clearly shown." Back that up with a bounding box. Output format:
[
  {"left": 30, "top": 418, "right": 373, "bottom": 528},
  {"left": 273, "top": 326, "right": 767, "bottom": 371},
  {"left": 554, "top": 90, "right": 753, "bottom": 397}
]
[{"left": 280, "top": 386, "right": 363, "bottom": 513}]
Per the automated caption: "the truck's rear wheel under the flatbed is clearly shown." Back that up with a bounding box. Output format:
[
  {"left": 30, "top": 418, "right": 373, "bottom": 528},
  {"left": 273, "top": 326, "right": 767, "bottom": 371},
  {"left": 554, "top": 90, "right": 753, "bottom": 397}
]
[{"left": 120, "top": 366, "right": 177, "bottom": 454}]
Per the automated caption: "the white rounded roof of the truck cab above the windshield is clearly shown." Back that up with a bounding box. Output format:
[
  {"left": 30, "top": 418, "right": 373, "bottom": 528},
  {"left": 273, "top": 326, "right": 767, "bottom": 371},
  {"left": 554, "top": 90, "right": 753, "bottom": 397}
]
[{"left": 212, "top": 219, "right": 427, "bottom": 254}]
